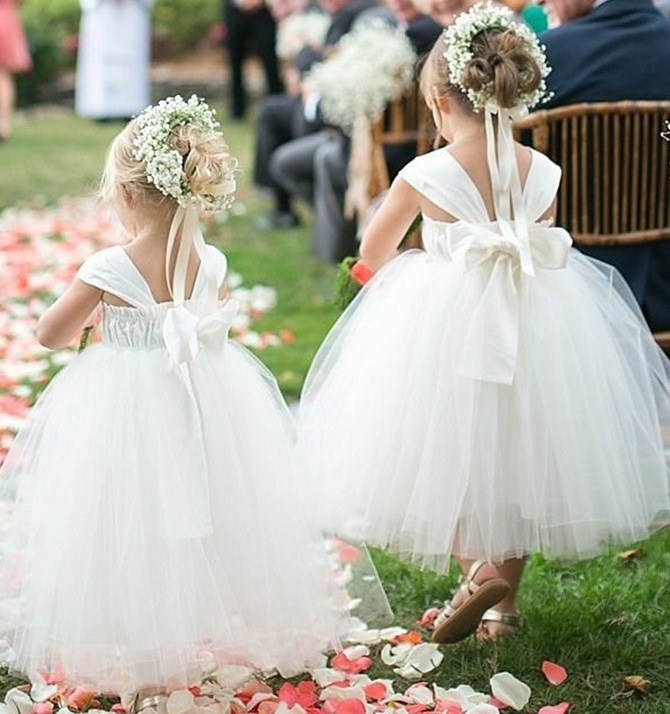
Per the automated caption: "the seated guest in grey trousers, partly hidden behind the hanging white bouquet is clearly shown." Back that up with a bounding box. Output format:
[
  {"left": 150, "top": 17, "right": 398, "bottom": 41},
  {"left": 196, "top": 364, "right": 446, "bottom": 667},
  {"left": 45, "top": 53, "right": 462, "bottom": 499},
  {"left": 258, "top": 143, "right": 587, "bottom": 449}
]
[{"left": 271, "top": 0, "right": 442, "bottom": 261}]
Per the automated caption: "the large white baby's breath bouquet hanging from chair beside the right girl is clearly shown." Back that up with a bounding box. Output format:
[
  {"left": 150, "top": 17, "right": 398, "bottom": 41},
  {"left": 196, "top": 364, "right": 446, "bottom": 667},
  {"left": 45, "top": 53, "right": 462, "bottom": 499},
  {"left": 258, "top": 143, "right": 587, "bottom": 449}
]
[{"left": 306, "top": 20, "right": 416, "bottom": 132}]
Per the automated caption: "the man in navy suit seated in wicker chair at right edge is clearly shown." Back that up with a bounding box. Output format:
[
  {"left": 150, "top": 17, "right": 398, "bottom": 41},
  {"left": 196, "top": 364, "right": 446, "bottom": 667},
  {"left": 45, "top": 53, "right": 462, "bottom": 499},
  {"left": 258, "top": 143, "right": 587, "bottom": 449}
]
[{"left": 540, "top": 0, "right": 670, "bottom": 330}]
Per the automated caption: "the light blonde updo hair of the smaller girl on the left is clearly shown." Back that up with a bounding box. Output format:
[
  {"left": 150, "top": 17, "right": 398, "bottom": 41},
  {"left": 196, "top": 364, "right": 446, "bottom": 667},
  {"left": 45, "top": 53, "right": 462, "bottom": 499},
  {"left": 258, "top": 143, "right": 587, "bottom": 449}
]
[{"left": 98, "top": 119, "right": 237, "bottom": 211}]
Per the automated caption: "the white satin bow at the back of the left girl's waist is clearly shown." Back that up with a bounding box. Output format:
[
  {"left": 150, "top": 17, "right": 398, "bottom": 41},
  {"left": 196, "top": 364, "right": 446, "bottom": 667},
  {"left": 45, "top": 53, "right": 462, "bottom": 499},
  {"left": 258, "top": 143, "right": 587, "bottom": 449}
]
[{"left": 163, "top": 300, "right": 239, "bottom": 365}]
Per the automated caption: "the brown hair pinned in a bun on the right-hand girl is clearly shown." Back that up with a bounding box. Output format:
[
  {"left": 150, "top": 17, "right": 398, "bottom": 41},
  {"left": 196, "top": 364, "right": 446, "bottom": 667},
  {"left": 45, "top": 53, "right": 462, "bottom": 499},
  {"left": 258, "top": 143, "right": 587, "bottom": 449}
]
[{"left": 419, "top": 29, "right": 542, "bottom": 129}]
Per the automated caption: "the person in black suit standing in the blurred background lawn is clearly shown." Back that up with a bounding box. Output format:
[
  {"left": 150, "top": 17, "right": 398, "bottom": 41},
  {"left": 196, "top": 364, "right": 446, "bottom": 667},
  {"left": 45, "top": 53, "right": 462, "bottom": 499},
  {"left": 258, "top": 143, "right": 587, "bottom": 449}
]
[{"left": 224, "top": 0, "right": 284, "bottom": 119}]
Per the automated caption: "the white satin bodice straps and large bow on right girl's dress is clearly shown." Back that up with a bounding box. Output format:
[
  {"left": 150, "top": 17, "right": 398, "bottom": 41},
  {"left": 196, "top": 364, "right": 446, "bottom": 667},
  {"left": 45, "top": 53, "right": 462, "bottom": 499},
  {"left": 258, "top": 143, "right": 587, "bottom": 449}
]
[{"left": 399, "top": 144, "right": 572, "bottom": 384}]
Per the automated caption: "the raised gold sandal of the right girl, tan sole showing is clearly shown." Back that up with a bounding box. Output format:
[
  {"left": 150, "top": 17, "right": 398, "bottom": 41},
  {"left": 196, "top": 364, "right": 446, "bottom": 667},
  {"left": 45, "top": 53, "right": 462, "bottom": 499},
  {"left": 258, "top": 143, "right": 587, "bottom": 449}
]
[{"left": 433, "top": 560, "right": 509, "bottom": 644}]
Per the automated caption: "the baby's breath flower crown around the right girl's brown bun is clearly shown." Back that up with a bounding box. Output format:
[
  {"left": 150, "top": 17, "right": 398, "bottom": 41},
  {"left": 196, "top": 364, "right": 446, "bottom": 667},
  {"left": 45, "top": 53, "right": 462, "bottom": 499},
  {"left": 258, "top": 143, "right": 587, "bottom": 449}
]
[{"left": 443, "top": 2, "right": 551, "bottom": 111}]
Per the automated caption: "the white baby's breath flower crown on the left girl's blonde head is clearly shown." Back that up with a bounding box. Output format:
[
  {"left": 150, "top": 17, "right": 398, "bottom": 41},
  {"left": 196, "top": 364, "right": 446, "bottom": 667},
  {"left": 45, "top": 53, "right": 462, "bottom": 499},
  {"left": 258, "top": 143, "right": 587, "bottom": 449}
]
[{"left": 133, "top": 94, "right": 236, "bottom": 211}]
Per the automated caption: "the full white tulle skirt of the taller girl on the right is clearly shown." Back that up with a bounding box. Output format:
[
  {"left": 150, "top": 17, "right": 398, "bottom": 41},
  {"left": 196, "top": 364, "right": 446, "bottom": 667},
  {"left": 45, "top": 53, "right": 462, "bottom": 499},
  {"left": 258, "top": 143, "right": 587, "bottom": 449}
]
[{"left": 298, "top": 250, "right": 670, "bottom": 571}]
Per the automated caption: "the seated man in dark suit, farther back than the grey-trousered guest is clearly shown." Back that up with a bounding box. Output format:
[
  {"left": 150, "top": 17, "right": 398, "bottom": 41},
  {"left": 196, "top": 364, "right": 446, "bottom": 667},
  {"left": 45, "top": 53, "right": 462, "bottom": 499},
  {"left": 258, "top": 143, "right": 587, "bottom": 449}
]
[{"left": 254, "top": 0, "right": 376, "bottom": 228}]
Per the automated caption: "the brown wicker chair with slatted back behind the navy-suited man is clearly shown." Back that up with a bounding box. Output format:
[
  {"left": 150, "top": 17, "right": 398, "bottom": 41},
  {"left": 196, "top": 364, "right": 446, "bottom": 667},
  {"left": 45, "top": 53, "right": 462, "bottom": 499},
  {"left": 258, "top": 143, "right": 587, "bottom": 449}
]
[{"left": 515, "top": 101, "right": 670, "bottom": 349}]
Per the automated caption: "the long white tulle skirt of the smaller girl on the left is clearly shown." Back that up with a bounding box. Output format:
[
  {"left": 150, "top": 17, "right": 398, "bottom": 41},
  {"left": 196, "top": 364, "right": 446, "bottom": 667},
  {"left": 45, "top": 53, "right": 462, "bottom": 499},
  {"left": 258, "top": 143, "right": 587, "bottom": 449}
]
[{"left": 0, "top": 343, "right": 343, "bottom": 692}]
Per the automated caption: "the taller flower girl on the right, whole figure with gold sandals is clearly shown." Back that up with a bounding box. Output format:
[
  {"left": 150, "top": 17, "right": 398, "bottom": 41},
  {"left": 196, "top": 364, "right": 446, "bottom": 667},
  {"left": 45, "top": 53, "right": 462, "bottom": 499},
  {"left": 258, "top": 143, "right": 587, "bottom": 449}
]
[{"left": 299, "top": 4, "right": 670, "bottom": 642}]
